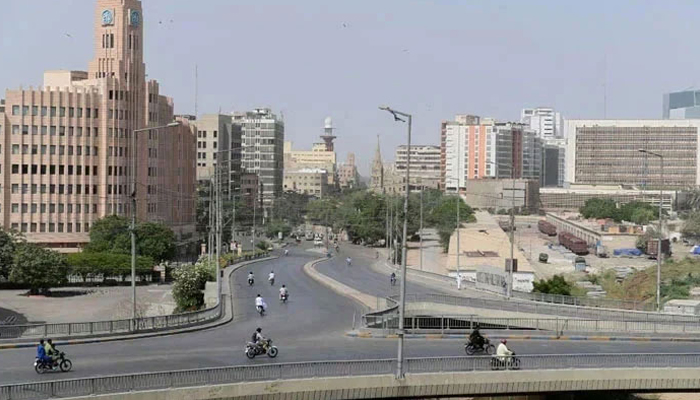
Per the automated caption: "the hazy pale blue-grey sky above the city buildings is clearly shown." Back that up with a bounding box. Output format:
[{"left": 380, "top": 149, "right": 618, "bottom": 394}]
[{"left": 0, "top": 0, "right": 700, "bottom": 174}]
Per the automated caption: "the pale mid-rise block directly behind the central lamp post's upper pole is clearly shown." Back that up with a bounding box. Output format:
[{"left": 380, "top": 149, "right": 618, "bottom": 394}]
[{"left": 395, "top": 145, "right": 440, "bottom": 190}]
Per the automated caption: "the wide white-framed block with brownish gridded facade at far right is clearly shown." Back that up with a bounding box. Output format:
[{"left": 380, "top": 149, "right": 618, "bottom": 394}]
[{"left": 565, "top": 120, "right": 700, "bottom": 189}]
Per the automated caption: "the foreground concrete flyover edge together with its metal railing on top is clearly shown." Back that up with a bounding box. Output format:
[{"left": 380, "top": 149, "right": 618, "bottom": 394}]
[{"left": 0, "top": 353, "right": 700, "bottom": 400}]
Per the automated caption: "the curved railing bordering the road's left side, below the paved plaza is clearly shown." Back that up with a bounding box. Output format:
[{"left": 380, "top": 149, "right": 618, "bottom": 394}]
[{"left": 0, "top": 253, "right": 267, "bottom": 339}]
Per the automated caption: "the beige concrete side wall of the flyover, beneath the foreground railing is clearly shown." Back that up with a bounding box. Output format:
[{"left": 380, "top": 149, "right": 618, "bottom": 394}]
[{"left": 52, "top": 368, "right": 700, "bottom": 400}]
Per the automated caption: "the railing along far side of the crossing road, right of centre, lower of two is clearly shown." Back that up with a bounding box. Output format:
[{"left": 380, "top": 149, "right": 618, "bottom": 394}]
[{"left": 363, "top": 314, "right": 700, "bottom": 335}]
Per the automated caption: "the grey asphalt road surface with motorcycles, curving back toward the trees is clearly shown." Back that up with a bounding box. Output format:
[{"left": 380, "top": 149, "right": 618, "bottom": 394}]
[{"left": 0, "top": 246, "right": 700, "bottom": 384}]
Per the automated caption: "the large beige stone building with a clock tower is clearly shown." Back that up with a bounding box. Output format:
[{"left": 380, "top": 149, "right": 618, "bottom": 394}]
[{"left": 0, "top": 0, "right": 196, "bottom": 252}]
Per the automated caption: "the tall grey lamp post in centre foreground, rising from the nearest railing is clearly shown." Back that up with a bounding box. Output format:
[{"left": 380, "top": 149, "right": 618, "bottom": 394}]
[{"left": 379, "top": 106, "right": 413, "bottom": 379}]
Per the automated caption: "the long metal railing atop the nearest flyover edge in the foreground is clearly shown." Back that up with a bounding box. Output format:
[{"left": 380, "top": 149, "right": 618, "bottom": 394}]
[{"left": 0, "top": 353, "right": 700, "bottom": 400}]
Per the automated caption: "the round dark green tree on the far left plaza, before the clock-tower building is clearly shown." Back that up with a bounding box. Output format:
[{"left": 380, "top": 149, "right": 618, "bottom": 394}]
[{"left": 10, "top": 243, "right": 69, "bottom": 294}]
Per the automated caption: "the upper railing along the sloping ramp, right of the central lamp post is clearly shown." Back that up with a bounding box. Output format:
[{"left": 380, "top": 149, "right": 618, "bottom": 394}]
[{"left": 406, "top": 293, "right": 700, "bottom": 323}]
